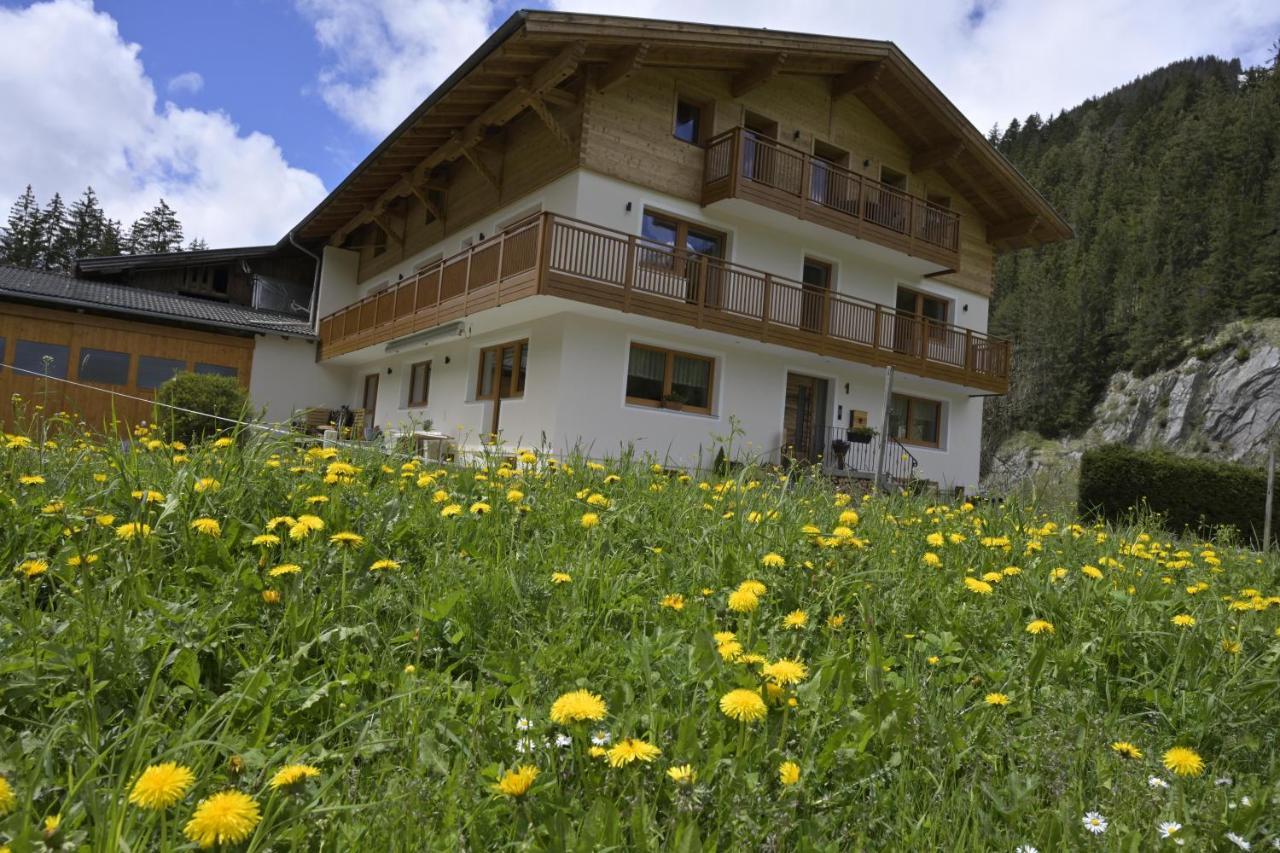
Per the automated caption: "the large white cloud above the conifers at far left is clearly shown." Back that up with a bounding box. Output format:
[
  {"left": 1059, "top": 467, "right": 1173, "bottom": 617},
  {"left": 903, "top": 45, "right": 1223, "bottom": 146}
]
[{"left": 0, "top": 0, "right": 325, "bottom": 246}]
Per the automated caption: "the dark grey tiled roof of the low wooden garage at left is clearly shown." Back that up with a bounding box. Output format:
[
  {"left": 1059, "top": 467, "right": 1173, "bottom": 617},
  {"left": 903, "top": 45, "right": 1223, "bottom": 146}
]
[{"left": 0, "top": 266, "right": 315, "bottom": 338}]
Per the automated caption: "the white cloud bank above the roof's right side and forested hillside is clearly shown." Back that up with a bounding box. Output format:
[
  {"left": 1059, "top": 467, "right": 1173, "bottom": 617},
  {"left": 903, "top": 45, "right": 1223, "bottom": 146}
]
[{"left": 550, "top": 0, "right": 1280, "bottom": 131}]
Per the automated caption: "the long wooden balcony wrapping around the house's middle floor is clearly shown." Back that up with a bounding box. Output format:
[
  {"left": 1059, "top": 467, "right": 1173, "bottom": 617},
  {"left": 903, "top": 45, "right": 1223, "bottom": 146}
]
[{"left": 320, "top": 214, "right": 1010, "bottom": 393}]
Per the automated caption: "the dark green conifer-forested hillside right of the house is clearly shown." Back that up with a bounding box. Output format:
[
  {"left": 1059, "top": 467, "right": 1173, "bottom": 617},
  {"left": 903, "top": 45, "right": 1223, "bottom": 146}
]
[{"left": 987, "top": 52, "right": 1280, "bottom": 447}]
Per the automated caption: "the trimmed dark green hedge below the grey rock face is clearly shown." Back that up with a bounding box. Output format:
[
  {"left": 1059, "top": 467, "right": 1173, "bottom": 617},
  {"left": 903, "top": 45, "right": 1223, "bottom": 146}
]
[{"left": 1080, "top": 444, "right": 1280, "bottom": 543}]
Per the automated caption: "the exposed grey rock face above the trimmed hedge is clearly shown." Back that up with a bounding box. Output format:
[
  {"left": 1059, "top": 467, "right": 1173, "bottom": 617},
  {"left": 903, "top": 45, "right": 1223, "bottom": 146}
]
[{"left": 984, "top": 319, "right": 1280, "bottom": 493}]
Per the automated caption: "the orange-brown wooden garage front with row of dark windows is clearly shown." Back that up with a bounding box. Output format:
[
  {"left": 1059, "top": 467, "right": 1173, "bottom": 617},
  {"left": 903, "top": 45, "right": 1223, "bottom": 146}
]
[{"left": 0, "top": 304, "right": 253, "bottom": 429}]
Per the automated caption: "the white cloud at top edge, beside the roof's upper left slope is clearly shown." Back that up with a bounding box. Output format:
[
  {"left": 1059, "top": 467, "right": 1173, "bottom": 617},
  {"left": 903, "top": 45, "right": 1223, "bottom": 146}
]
[{"left": 297, "top": 0, "right": 498, "bottom": 137}]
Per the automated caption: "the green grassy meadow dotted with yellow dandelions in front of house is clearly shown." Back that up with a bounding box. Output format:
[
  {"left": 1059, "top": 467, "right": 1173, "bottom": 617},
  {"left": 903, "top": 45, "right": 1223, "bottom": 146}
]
[{"left": 0, "top": 409, "right": 1280, "bottom": 852}]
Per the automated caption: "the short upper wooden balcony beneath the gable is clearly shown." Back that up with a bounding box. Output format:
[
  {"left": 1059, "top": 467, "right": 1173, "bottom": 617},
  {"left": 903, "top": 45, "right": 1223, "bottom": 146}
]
[{"left": 703, "top": 127, "right": 960, "bottom": 270}]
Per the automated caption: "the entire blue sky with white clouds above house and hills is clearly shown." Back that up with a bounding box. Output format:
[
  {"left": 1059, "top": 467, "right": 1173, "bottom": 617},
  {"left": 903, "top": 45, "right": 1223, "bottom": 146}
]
[{"left": 0, "top": 0, "right": 1280, "bottom": 246}]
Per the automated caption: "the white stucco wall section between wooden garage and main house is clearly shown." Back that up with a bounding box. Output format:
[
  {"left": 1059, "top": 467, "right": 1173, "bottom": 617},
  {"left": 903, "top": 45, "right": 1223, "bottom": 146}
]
[{"left": 248, "top": 334, "right": 351, "bottom": 424}]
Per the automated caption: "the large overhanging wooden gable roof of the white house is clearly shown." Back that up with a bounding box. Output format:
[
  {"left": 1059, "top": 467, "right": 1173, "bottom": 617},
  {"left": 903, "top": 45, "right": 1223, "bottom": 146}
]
[{"left": 292, "top": 12, "right": 1071, "bottom": 248}]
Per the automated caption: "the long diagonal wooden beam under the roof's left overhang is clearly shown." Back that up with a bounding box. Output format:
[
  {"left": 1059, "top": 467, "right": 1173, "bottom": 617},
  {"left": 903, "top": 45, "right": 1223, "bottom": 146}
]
[{"left": 330, "top": 41, "right": 586, "bottom": 245}]
